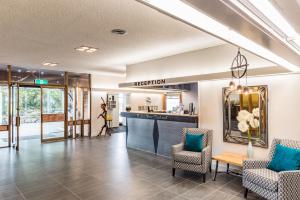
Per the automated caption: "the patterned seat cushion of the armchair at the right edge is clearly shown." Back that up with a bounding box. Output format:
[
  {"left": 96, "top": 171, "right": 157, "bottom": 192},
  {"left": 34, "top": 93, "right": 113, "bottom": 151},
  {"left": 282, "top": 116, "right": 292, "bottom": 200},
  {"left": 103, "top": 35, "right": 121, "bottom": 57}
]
[{"left": 243, "top": 169, "right": 279, "bottom": 191}]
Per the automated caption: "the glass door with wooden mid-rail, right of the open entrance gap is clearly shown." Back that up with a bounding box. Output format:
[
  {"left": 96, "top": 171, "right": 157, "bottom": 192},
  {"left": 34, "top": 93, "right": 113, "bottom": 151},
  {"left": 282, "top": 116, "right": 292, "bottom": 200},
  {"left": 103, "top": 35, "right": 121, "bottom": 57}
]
[{"left": 41, "top": 86, "right": 66, "bottom": 142}]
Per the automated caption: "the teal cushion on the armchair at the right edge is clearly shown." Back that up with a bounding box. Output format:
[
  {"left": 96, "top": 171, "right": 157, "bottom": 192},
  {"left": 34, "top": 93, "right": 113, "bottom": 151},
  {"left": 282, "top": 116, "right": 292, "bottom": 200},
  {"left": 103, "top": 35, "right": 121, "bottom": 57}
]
[{"left": 267, "top": 144, "right": 300, "bottom": 172}]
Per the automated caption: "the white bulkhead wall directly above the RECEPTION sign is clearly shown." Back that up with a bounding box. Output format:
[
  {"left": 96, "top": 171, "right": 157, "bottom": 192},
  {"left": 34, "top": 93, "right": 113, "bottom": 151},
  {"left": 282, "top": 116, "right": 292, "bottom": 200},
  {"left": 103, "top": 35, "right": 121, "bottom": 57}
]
[{"left": 126, "top": 44, "right": 275, "bottom": 82}]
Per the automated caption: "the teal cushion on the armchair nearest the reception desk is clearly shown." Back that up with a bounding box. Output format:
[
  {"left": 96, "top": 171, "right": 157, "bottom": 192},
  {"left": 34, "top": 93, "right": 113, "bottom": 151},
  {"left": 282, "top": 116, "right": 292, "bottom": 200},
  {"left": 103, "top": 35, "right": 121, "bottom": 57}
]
[{"left": 184, "top": 132, "right": 203, "bottom": 152}]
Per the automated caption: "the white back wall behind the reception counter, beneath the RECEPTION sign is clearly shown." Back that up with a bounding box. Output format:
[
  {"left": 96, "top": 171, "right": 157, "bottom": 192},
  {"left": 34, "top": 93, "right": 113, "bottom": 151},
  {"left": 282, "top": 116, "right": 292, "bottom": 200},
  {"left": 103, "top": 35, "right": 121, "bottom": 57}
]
[{"left": 127, "top": 93, "right": 162, "bottom": 111}]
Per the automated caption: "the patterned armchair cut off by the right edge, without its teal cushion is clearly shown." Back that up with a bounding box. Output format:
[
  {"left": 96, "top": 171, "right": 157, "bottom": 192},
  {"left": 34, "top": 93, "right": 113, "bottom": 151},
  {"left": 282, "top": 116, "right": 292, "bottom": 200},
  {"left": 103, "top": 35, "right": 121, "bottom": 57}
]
[{"left": 243, "top": 139, "right": 300, "bottom": 200}]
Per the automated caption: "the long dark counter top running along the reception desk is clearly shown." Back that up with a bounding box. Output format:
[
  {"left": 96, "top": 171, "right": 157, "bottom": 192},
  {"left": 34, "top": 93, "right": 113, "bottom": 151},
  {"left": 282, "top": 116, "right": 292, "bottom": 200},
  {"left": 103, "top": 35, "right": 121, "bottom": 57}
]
[{"left": 121, "top": 111, "right": 198, "bottom": 123}]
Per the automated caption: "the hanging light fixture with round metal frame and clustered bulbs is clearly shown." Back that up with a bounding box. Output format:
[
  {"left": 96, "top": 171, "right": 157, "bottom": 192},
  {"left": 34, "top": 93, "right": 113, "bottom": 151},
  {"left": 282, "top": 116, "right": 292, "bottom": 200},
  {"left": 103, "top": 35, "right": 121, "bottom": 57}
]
[{"left": 229, "top": 48, "right": 250, "bottom": 94}]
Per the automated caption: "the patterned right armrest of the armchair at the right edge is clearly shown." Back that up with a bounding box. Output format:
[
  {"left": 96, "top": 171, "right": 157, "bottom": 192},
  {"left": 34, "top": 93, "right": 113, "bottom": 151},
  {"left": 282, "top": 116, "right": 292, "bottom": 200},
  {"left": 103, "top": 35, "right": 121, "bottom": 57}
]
[{"left": 278, "top": 170, "right": 300, "bottom": 199}]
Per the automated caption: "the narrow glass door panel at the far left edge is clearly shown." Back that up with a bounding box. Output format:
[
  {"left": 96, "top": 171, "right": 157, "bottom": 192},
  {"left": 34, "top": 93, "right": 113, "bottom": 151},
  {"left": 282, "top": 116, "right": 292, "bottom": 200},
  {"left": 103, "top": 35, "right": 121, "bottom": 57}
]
[{"left": 0, "top": 85, "right": 10, "bottom": 147}]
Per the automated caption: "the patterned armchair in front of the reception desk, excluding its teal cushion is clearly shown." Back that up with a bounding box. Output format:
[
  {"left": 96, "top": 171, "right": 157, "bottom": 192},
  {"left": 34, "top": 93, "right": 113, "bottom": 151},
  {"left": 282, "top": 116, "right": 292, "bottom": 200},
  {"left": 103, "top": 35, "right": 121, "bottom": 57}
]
[{"left": 172, "top": 128, "right": 212, "bottom": 182}]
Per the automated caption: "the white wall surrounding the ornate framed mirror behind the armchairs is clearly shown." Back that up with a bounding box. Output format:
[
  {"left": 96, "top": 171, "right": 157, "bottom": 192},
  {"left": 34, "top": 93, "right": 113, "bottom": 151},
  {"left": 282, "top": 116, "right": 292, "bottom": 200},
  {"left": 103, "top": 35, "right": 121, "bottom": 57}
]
[{"left": 198, "top": 74, "right": 300, "bottom": 158}]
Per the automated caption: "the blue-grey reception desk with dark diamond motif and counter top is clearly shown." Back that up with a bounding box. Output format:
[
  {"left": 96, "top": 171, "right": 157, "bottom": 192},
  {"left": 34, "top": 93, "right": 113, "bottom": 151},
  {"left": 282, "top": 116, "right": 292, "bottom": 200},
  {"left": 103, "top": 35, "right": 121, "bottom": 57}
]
[{"left": 121, "top": 112, "right": 198, "bottom": 157}]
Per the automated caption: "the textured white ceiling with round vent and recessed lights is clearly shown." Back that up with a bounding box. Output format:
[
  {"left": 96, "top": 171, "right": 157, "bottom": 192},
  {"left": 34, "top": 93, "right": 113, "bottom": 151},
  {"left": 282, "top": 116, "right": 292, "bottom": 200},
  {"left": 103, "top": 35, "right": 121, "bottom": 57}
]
[{"left": 0, "top": 0, "right": 224, "bottom": 74}]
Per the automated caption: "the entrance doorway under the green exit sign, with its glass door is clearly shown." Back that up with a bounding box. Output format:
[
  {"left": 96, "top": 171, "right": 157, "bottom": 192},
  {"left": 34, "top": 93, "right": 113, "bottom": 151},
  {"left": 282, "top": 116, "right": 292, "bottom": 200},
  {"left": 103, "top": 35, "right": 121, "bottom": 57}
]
[{"left": 12, "top": 84, "right": 65, "bottom": 149}]
